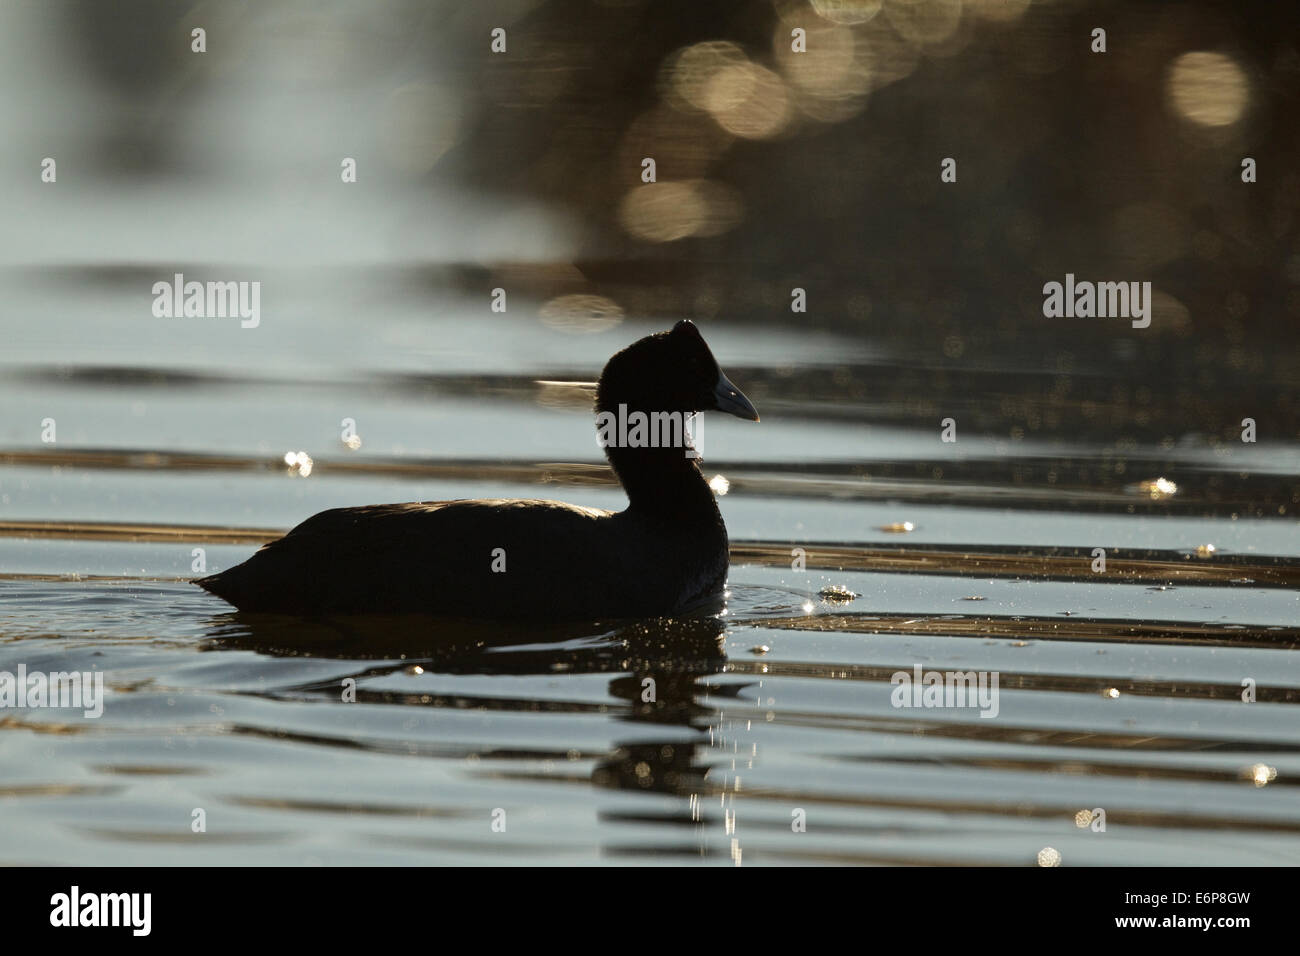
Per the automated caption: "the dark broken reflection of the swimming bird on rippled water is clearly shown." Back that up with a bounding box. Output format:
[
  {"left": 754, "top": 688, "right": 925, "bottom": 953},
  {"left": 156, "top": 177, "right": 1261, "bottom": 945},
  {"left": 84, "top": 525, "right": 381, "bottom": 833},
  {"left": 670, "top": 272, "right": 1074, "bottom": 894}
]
[{"left": 204, "top": 611, "right": 749, "bottom": 862}]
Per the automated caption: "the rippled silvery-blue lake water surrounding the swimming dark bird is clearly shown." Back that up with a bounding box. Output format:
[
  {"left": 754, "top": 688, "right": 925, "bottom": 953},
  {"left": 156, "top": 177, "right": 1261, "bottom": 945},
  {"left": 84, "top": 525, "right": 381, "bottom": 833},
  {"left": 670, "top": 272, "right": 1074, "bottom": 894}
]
[{"left": 0, "top": 265, "right": 1300, "bottom": 865}]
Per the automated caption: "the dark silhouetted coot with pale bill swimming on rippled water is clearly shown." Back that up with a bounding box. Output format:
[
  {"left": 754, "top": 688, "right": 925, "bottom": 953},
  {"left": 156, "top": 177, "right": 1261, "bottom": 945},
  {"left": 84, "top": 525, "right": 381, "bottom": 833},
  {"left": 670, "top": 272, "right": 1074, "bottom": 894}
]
[{"left": 195, "top": 320, "right": 758, "bottom": 620}]
